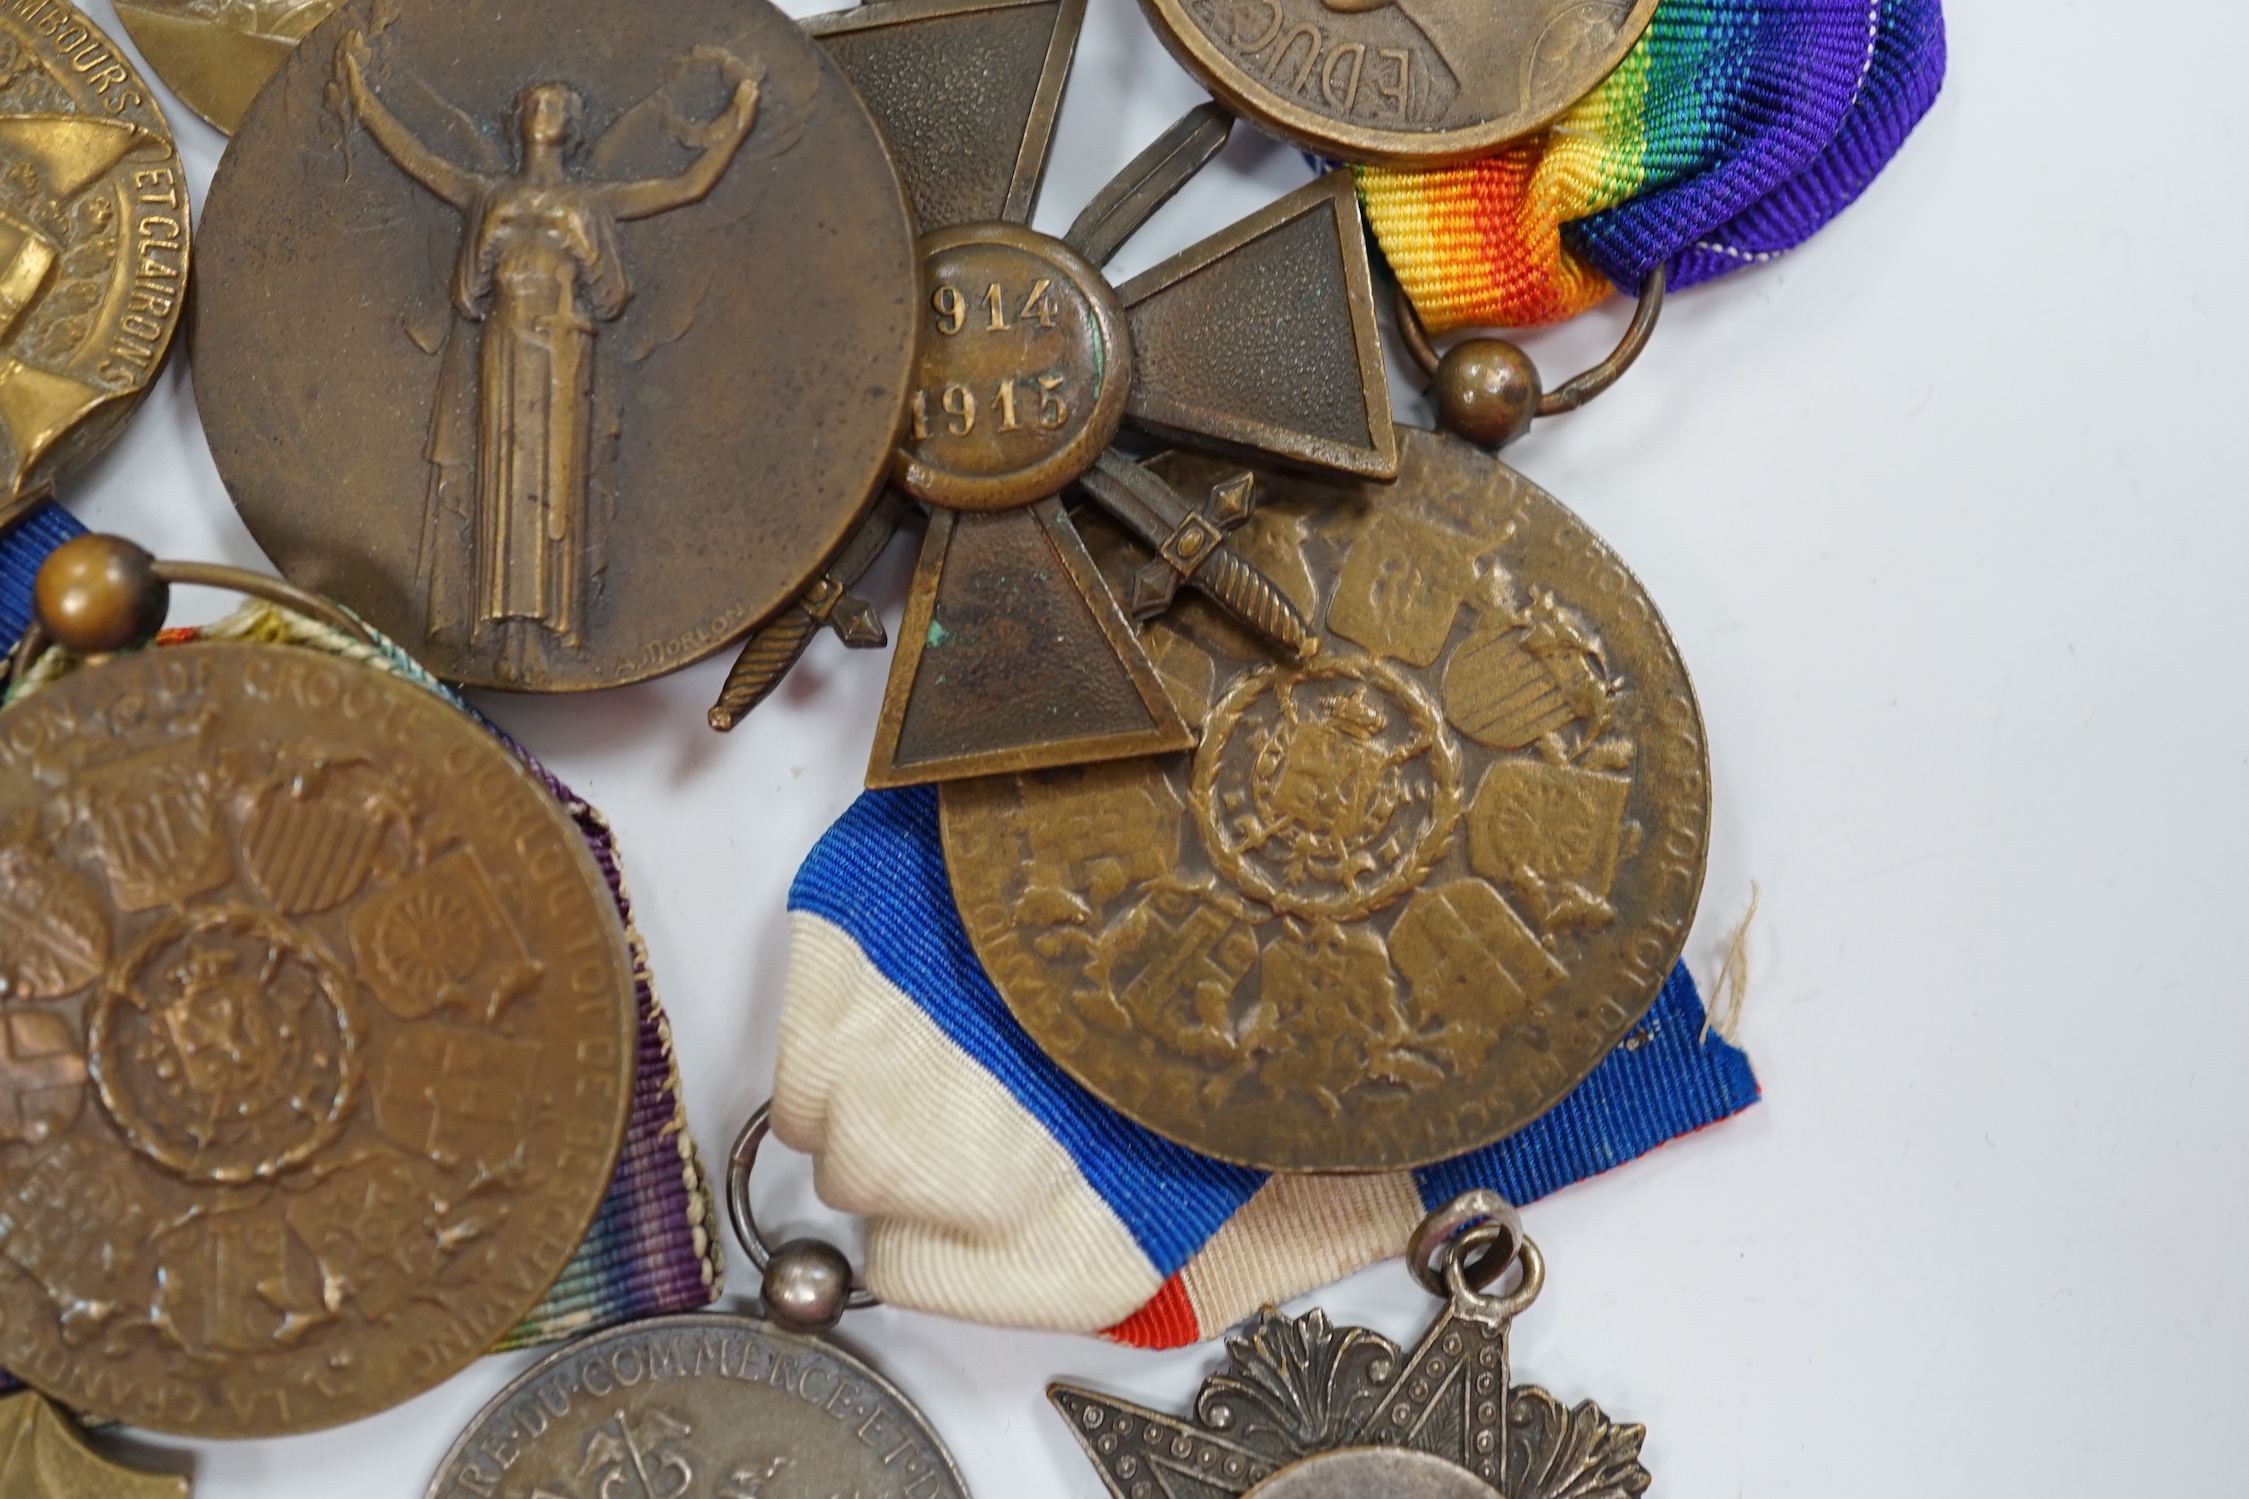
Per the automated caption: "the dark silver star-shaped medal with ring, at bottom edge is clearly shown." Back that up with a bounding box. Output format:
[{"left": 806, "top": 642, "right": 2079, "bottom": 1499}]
[{"left": 1046, "top": 1193, "right": 1651, "bottom": 1499}]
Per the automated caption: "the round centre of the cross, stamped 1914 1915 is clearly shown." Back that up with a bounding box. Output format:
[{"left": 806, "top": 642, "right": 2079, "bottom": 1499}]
[{"left": 897, "top": 222, "right": 1131, "bottom": 510}]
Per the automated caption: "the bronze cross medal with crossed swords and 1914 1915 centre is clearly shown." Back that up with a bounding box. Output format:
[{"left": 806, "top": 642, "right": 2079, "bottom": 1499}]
[{"left": 711, "top": 0, "right": 1397, "bottom": 787}]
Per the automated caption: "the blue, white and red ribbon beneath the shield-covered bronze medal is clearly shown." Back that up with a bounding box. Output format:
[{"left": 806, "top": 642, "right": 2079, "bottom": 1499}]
[{"left": 774, "top": 787, "right": 1756, "bottom": 1348}]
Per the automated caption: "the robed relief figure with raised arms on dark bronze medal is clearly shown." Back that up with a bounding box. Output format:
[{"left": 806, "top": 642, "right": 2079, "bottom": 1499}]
[{"left": 335, "top": 31, "right": 765, "bottom": 676}]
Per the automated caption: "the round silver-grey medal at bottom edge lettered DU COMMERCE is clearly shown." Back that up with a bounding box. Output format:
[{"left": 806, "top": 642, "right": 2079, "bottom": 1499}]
[{"left": 427, "top": 1312, "right": 967, "bottom": 1499}]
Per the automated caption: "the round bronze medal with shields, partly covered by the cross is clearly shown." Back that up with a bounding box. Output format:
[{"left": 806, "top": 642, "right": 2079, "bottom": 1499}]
[{"left": 942, "top": 431, "right": 1709, "bottom": 1171}]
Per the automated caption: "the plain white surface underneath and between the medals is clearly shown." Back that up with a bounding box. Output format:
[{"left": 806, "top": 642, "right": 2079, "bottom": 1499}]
[{"left": 52, "top": 0, "right": 2249, "bottom": 1499}]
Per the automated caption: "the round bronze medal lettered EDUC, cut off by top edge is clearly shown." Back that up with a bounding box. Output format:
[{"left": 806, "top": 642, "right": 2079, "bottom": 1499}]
[{"left": 1140, "top": 0, "right": 1655, "bottom": 166}]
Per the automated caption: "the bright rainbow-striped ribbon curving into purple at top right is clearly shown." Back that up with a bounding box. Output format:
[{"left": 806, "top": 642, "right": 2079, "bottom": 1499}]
[{"left": 1358, "top": 0, "right": 1945, "bottom": 333}]
